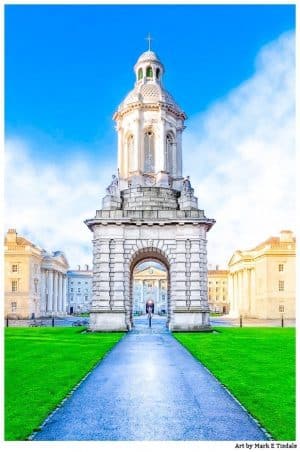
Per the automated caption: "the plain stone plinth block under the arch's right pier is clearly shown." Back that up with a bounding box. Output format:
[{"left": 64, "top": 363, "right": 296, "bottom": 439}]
[{"left": 169, "top": 310, "right": 212, "bottom": 332}]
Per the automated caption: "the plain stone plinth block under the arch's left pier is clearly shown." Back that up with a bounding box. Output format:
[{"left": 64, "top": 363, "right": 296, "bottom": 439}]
[{"left": 90, "top": 311, "right": 128, "bottom": 332}]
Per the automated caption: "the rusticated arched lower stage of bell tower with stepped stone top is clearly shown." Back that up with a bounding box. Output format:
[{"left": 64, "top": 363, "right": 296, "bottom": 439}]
[{"left": 86, "top": 187, "right": 214, "bottom": 331}]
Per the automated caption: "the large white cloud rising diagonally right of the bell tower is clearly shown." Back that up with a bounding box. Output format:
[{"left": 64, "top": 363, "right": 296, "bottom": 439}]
[{"left": 184, "top": 32, "right": 296, "bottom": 266}]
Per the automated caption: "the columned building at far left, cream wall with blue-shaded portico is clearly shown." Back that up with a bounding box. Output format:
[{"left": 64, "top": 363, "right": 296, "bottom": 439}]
[{"left": 4, "top": 229, "right": 68, "bottom": 319}]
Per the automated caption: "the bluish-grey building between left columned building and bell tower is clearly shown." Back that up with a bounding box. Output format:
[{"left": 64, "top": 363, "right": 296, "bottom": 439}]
[{"left": 68, "top": 265, "right": 93, "bottom": 314}]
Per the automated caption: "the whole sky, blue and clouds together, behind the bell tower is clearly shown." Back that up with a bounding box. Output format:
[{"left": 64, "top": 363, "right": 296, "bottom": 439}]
[{"left": 5, "top": 5, "right": 296, "bottom": 267}]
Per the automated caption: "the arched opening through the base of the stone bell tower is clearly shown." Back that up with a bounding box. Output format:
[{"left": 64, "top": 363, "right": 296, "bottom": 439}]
[{"left": 129, "top": 250, "right": 171, "bottom": 327}]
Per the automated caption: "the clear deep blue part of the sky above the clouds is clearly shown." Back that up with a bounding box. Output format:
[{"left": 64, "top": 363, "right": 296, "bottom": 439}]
[{"left": 5, "top": 5, "right": 294, "bottom": 158}]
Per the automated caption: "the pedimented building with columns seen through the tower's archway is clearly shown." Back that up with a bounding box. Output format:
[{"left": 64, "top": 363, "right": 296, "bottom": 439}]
[{"left": 133, "top": 265, "right": 167, "bottom": 315}]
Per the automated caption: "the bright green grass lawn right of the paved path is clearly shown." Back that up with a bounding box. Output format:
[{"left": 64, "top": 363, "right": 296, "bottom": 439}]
[{"left": 174, "top": 327, "right": 296, "bottom": 441}]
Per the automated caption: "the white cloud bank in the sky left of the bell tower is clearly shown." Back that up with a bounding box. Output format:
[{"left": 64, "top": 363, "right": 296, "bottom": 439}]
[{"left": 5, "top": 138, "right": 114, "bottom": 268}]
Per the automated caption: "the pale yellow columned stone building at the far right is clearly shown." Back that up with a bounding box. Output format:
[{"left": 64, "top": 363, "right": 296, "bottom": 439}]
[{"left": 228, "top": 231, "right": 296, "bottom": 319}]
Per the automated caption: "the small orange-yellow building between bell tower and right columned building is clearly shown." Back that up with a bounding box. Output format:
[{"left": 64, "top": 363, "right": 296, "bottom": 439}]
[{"left": 207, "top": 266, "right": 229, "bottom": 314}]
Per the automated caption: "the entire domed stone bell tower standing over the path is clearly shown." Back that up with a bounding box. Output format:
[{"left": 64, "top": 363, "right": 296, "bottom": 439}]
[{"left": 85, "top": 45, "right": 215, "bottom": 331}]
